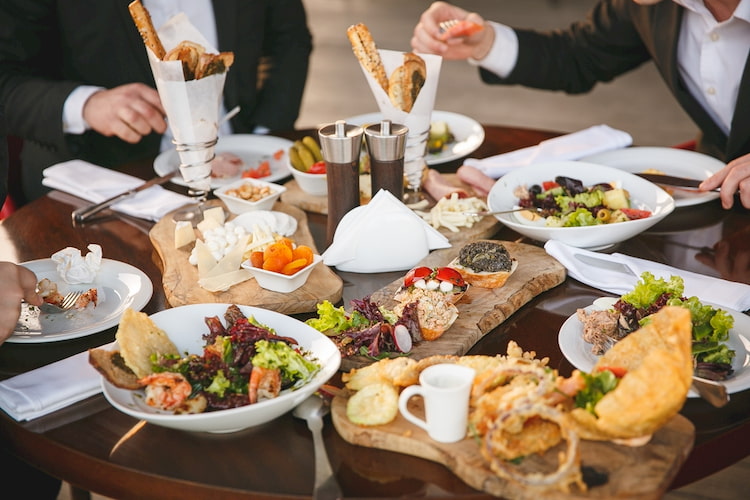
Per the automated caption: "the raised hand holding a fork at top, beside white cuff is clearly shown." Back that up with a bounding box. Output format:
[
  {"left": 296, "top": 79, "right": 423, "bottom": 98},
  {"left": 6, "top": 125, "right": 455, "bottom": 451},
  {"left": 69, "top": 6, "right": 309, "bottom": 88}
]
[{"left": 411, "top": 2, "right": 495, "bottom": 60}]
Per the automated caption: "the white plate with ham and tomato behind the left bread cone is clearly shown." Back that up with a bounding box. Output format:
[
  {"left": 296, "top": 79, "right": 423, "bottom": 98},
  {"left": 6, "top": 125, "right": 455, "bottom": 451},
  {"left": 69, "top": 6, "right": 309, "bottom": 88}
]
[{"left": 154, "top": 134, "right": 293, "bottom": 189}]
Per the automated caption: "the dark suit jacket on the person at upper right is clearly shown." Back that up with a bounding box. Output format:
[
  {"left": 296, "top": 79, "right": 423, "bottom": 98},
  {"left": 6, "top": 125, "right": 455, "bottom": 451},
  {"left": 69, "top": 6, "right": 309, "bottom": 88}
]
[{"left": 481, "top": 0, "right": 750, "bottom": 161}]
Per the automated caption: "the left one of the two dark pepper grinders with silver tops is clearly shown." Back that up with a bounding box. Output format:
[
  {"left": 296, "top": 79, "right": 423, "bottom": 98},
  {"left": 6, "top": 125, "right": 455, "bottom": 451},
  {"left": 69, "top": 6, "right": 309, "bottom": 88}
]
[{"left": 318, "top": 120, "right": 364, "bottom": 246}]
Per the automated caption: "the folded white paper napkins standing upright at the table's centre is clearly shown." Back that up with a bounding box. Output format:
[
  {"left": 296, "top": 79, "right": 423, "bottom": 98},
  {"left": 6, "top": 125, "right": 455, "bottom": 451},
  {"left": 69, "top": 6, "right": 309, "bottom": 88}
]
[{"left": 323, "top": 189, "right": 451, "bottom": 273}]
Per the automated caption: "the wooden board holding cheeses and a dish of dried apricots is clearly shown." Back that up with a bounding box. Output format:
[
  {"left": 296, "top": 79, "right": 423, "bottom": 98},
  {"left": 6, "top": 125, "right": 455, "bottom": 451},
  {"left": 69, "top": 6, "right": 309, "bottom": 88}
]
[{"left": 149, "top": 201, "right": 344, "bottom": 314}]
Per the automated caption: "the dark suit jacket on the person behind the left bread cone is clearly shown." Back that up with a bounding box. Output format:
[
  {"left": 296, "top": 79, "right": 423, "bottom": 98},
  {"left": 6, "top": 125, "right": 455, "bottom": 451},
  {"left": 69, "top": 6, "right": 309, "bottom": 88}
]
[{"left": 0, "top": 0, "right": 312, "bottom": 203}]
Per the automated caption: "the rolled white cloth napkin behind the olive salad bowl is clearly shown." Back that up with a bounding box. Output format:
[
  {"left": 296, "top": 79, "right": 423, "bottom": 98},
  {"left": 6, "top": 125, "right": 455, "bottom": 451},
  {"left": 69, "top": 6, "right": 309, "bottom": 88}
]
[{"left": 464, "top": 125, "right": 633, "bottom": 179}]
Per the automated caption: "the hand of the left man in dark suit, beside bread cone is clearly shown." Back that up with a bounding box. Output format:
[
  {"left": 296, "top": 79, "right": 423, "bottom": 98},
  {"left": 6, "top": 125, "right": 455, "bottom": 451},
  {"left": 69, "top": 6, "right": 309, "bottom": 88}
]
[{"left": 83, "top": 83, "right": 167, "bottom": 144}]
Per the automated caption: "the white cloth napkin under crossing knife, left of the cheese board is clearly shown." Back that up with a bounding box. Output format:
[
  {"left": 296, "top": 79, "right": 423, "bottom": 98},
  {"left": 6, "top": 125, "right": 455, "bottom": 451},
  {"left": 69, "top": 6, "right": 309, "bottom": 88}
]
[{"left": 42, "top": 160, "right": 192, "bottom": 221}]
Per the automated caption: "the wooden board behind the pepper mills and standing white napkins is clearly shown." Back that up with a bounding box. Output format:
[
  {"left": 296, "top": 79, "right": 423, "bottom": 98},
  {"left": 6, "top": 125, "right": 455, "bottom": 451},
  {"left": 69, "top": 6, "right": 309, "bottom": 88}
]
[{"left": 281, "top": 174, "right": 500, "bottom": 243}]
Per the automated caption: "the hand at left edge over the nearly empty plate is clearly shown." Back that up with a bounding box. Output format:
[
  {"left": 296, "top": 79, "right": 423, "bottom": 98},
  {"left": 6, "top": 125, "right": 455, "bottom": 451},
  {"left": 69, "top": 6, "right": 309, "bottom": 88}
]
[{"left": 0, "top": 262, "right": 42, "bottom": 344}]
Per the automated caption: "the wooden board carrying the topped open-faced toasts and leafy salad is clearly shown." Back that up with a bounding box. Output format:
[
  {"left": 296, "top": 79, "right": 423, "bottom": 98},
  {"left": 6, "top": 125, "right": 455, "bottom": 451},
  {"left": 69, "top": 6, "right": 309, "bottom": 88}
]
[{"left": 341, "top": 241, "right": 566, "bottom": 371}]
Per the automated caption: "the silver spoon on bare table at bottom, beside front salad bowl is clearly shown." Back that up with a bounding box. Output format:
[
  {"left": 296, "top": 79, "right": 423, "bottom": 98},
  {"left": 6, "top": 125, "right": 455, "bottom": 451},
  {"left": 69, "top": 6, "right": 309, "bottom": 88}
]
[{"left": 292, "top": 394, "right": 342, "bottom": 500}]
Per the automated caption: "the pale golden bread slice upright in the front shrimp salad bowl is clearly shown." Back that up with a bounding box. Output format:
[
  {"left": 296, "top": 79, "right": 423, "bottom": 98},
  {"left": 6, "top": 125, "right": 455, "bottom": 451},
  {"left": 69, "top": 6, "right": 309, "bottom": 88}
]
[{"left": 115, "top": 308, "right": 179, "bottom": 378}]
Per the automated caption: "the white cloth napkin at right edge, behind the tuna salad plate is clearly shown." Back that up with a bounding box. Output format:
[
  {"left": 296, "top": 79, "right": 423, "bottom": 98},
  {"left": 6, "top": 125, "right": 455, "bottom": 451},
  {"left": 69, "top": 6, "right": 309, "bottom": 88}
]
[{"left": 544, "top": 240, "right": 750, "bottom": 311}]
